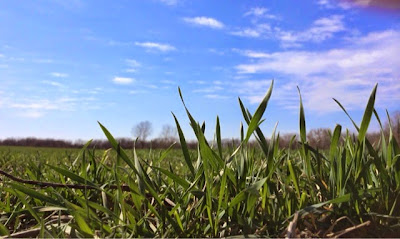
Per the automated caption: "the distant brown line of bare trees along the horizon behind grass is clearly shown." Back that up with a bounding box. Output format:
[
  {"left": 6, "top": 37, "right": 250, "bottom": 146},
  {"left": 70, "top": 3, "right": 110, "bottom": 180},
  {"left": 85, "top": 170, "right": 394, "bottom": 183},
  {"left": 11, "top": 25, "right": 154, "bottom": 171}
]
[{"left": 0, "top": 111, "right": 400, "bottom": 150}]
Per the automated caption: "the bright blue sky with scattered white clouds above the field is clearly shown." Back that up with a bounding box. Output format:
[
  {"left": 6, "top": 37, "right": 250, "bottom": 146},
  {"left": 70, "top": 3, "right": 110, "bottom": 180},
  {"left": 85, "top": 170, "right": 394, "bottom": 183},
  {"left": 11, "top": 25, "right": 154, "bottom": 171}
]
[{"left": 0, "top": 0, "right": 400, "bottom": 140}]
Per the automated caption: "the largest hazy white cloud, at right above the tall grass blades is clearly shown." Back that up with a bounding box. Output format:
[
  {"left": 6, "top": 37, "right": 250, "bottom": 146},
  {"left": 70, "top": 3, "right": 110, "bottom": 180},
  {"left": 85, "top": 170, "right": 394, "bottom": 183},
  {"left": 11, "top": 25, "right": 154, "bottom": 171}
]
[{"left": 236, "top": 30, "right": 400, "bottom": 112}]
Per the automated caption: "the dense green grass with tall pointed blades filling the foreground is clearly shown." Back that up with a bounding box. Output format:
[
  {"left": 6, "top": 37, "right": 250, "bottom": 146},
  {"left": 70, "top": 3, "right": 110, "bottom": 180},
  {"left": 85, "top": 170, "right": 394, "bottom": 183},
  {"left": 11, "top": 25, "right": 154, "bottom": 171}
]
[{"left": 0, "top": 82, "right": 400, "bottom": 237}]
